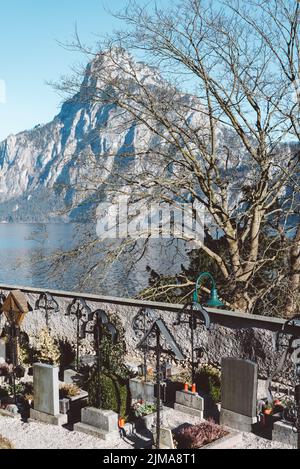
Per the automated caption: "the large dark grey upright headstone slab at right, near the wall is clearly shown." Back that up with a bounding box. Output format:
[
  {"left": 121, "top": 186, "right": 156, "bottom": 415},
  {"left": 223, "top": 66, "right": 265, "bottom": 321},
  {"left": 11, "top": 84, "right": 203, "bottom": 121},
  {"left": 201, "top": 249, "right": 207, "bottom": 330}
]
[{"left": 220, "top": 358, "right": 258, "bottom": 432}]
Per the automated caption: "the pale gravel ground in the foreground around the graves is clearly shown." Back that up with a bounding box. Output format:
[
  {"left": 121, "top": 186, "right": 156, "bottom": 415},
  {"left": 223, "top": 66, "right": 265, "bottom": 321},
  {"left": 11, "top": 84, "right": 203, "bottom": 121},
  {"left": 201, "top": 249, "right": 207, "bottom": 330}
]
[{"left": 0, "top": 413, "right": 291, "bottom": 450}]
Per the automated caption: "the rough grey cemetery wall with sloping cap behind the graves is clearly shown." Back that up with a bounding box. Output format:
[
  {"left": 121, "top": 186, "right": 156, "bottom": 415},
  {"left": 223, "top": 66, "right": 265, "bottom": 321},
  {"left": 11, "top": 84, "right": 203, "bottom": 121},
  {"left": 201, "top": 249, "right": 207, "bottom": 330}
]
[{"left": 0, "top": 286, "right": 300, "bottom": 380}]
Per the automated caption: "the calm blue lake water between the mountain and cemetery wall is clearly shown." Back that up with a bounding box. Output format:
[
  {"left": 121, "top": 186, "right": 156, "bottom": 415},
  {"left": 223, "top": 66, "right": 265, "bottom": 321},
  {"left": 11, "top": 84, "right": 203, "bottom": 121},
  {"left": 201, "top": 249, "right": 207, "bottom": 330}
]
[{"left": 0, "top": 223, "right": 187, "bottom": 297}]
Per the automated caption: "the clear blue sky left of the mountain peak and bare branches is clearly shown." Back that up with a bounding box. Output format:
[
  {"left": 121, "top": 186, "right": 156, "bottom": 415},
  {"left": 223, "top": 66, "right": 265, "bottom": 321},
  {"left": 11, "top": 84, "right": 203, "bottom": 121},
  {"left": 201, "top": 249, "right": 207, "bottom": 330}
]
[{"left": 0, "top": 0, "right": 169, "bottom": 141}]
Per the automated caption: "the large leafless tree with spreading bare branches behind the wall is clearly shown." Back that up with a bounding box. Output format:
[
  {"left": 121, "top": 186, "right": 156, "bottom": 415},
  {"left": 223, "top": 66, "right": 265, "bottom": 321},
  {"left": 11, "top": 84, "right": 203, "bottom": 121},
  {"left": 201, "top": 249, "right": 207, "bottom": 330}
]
[{"left": 55, "top": 0, "right": 300, "bottom": 315}]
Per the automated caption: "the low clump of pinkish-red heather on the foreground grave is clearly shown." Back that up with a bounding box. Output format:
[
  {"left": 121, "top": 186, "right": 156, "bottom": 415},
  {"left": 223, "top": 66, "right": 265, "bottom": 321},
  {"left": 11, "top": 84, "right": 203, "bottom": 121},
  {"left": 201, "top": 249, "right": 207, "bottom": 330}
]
[{"left": 174, "top": 421, "right": 228, "bottom": 449}]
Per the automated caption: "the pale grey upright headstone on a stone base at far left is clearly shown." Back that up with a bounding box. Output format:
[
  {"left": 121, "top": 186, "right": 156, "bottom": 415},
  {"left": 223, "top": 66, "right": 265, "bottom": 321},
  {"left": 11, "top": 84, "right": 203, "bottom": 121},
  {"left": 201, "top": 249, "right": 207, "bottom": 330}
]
[{"left": 30, "top": 363, "right": 68, "bottom": 425}]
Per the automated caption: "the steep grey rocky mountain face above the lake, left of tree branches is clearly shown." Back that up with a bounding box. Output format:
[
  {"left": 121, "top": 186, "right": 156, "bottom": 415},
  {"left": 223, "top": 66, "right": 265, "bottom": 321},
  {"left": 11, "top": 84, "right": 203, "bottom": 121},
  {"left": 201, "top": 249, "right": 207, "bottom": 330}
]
[{"left": 0, "top": 50, "right": 172, "bottom": 221}]
